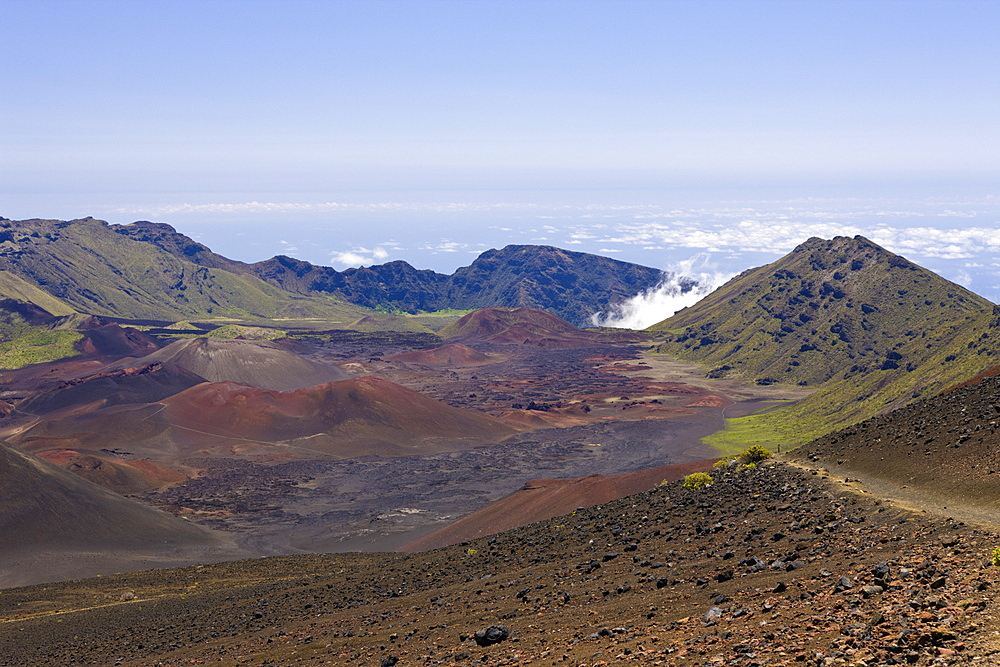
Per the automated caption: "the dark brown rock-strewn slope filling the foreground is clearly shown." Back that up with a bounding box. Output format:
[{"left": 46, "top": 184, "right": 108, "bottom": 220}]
[{"left": 0, "top": 463, "right": 1000, "bottom": 667}]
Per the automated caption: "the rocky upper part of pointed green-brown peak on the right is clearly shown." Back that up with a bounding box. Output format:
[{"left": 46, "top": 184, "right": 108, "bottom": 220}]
[{"left": 652, "top": 236, "right": 992, "bottom": 384}]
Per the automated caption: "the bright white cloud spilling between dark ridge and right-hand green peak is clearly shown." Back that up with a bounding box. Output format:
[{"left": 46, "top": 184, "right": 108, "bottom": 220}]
[{"left": 591, "top": 254, "right": 735, "bottom": 329}]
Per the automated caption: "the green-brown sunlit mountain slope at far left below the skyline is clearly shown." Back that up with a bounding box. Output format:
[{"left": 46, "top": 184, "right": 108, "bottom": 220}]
[{"left": 0, "top": 218, "right": 368, "bottom": 322}]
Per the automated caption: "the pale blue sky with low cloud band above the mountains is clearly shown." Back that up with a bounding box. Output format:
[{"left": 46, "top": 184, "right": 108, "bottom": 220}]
[{"left": 0, "top": 0, "right": 1000, "bottom": 310}]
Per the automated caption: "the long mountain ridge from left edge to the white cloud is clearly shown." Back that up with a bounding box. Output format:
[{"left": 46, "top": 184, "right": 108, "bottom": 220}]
[{"left": 0, "top": 217, "right": 680, "bottom": 325}]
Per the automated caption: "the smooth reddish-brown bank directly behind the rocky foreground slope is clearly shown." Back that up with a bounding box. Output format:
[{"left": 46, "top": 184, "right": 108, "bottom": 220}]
[{"left": 399, "top": 459, "right": 718, "bottom": 551}]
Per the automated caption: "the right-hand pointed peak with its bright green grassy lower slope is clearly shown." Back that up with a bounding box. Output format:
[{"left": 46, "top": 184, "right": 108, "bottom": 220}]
[{"left": 651, "top": 236, "right": 1000, "bottom": 446}]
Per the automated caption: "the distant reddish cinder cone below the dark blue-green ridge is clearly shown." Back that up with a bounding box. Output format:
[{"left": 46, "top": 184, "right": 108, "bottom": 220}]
[{"left": 438, "top": 308, "right": 620, "bottom": 349}]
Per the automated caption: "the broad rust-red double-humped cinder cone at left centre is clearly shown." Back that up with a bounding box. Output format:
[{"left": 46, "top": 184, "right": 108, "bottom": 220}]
[{"left": 7, "top": 377, "right": 516, "bottom": 480}]
